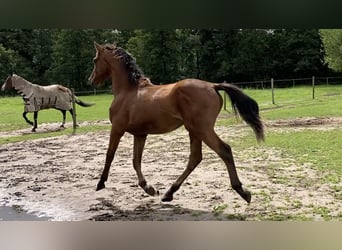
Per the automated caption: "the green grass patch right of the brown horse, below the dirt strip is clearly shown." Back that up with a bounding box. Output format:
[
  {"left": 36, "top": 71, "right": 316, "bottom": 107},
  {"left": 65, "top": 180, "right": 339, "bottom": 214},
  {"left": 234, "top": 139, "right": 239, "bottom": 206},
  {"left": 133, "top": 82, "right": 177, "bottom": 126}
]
[{"left": 230, "top": 128, "right": 342, "bottom": 181}]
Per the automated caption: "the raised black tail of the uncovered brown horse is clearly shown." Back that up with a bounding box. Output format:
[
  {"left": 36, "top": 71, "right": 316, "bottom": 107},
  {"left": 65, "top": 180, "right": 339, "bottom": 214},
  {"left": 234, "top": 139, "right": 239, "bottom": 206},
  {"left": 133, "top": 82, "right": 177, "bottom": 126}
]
[{"left": 215, "top": 83, "right": 265, "bottom": 141}]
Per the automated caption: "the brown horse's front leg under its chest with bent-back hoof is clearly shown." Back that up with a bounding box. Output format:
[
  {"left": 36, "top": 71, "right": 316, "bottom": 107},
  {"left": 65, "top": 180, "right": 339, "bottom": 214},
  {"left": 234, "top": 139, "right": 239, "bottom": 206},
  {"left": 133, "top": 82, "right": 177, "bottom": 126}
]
[{"left": 133, "top": 135, "right": 159, "bottom": 196}]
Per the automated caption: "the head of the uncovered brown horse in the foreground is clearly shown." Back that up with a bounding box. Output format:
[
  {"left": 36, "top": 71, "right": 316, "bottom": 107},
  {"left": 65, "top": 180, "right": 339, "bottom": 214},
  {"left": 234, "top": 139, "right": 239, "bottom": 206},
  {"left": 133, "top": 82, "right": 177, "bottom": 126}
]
[{"left": 88, "top": 42, "right": 110, "bottom": 87}]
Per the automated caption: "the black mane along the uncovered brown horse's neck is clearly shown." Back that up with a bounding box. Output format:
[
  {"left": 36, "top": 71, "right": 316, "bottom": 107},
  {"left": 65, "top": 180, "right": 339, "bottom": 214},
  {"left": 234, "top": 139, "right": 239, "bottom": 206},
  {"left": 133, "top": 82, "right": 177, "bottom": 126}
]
[{"left": 106, "top": 45, "right": 144, "bottom": 84}]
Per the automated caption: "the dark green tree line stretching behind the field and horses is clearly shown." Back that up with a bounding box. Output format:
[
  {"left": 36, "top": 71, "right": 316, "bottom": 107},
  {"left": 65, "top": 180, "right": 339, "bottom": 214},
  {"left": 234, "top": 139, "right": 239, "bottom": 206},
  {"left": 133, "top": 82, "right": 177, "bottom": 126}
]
[{"left": 0, "top": 29, "right": 338, "bottom": 91}]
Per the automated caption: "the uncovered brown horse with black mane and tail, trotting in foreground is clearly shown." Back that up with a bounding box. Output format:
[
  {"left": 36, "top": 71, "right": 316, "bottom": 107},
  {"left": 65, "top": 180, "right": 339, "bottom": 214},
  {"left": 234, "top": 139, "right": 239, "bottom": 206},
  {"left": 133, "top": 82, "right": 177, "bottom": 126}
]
[{"left": 89, "top": 43, "right": 264, "bottom": 203}]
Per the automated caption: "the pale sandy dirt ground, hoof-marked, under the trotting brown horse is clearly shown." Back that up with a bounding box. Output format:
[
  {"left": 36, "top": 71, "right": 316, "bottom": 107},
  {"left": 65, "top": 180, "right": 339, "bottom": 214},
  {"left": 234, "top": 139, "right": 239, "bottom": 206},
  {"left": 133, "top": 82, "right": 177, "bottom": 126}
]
[{"left": 0, "top": 118, "right": 342, "bottom": 221}]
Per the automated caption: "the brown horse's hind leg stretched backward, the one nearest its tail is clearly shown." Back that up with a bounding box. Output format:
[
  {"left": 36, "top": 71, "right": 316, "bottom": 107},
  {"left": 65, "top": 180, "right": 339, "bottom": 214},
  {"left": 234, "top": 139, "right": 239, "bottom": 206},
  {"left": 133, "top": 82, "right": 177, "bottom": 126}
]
[{"left": 203, "top": 130, "right": 251, "bottom": 203}]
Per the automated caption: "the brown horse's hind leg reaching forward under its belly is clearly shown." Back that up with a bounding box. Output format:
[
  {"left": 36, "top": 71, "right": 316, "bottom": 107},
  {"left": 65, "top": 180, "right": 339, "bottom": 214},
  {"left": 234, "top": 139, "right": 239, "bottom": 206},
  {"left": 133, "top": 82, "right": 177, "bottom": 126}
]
[{"left": 162, "top": 134, "right": 202, "bottom": 201}]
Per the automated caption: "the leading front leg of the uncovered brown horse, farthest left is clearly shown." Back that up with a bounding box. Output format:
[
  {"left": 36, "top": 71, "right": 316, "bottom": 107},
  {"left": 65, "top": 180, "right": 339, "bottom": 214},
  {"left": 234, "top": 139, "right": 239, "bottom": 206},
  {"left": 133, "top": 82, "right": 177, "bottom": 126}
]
[{"left": 96, "top": 127, "right": 124, "bottom": 191}]
